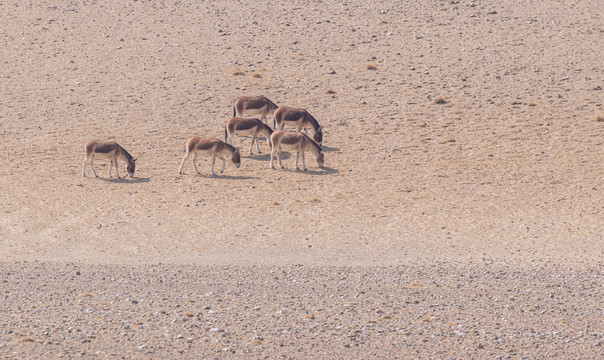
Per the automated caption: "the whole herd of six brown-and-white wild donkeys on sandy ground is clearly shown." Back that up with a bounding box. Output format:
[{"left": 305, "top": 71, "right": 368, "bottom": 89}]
[{"left": 82, "top": 96, "right": 324, "bottom": 179}]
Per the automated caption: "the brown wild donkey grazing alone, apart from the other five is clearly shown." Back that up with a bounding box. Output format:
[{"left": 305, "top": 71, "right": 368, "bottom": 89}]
[{"left": 82, "top": 140, "right": 136, "bottom": 179}]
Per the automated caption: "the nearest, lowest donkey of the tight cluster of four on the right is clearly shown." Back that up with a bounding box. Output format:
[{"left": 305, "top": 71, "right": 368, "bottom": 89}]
[{"left": 269, "top": 130, "right": 325, "bottom": 171}]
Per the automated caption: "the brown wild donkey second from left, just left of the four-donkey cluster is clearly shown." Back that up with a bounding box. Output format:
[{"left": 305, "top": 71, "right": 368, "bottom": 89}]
[{"left": 178, "top": 136, "right": 241, "bottom": 175}]
